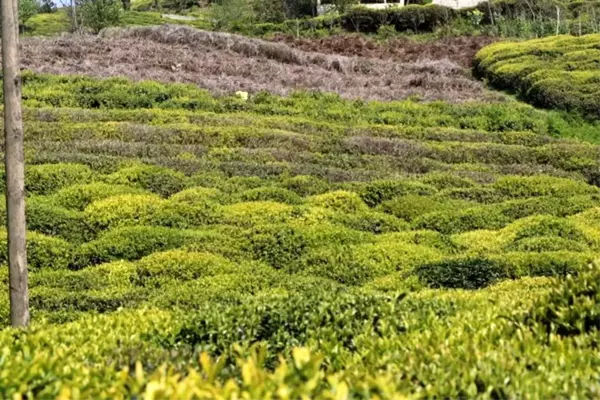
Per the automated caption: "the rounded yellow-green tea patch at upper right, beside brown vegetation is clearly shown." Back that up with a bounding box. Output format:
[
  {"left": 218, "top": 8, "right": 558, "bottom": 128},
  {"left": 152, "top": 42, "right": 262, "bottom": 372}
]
[{"left": 474, "top": 34, "right": 600, "bottom": 118}]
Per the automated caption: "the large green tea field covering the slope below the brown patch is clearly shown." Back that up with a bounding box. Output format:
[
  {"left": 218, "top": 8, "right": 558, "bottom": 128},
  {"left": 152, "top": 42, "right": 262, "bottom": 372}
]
[{"left": 0, "top": 73, "right": 600, "bottom": 399}]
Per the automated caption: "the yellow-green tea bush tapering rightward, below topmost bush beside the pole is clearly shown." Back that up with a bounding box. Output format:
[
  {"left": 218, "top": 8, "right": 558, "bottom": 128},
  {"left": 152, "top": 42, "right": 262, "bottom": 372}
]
[{"left": 52, "top": 182, "right": 145, "bottom": 211}]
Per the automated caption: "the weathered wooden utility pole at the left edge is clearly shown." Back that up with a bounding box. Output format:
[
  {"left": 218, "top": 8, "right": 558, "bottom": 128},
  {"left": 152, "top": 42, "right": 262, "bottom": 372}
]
[{"left": 0, "top": 0, "right": 29, "bottom": 327}]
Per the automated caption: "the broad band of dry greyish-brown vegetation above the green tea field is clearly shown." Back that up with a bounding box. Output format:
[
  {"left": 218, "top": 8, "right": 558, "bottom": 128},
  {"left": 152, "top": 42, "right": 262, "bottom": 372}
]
[{"left": 22, "top": 26, "right": 498, "bottom": 102}]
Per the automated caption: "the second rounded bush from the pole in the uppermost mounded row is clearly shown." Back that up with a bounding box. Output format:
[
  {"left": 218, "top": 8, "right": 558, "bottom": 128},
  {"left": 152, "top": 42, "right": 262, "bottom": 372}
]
[{"left": 105, "top": 165, "right": 186, "bottom": 197}]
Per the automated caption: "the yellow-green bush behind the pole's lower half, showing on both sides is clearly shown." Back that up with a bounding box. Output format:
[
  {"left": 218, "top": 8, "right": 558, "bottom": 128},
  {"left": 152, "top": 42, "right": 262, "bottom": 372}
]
[{"left": 0, "top": 230, "right": 72, "bottom": 270}]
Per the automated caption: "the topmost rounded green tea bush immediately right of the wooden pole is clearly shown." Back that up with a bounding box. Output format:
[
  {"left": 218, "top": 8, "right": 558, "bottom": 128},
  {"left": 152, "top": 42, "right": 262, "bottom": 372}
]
[{"left": 25, "top": 163, "right": 93, "bottom": 194}]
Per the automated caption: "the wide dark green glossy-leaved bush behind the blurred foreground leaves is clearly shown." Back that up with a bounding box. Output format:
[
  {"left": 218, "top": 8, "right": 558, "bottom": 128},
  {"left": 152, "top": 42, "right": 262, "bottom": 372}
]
[{"left": 175, "top": 292, "right": 403, "bottom": 364}]
